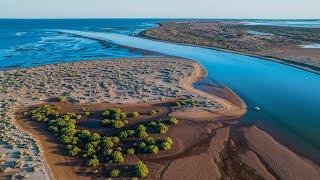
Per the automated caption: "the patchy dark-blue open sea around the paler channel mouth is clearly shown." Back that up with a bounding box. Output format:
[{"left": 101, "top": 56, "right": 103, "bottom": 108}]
[{"left": 0, "top": 19, "right": 163, "bottom": 70}]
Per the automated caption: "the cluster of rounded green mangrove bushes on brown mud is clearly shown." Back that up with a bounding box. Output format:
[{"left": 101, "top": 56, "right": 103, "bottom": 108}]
[{"left": 25, "top": 105, "right": 179, "bottom": 178}]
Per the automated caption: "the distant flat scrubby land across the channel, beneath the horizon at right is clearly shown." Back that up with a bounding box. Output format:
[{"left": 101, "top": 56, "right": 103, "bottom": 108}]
[{"left": 140, "top": 21, "right": 320, "bottom": 73}]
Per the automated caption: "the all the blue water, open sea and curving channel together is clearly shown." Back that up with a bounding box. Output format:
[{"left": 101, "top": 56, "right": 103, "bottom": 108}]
[{"left": 0, "top": 19, "right": 320, "bottom": 162}]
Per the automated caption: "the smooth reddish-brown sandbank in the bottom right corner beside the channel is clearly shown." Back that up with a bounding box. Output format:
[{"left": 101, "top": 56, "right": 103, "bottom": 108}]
[{"left": 244, "top": 126, "right": 320, "bottom": 180}]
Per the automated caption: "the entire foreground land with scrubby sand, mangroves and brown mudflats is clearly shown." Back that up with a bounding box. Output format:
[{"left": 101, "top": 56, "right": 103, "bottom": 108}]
[{"left": 0, "top": 57, "right": 320, "bottom": 179}]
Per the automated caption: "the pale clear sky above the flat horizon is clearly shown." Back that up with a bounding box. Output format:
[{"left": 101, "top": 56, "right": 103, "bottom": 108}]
[{"left": 0, "top": 0, "right": 320, "bottom": 19}]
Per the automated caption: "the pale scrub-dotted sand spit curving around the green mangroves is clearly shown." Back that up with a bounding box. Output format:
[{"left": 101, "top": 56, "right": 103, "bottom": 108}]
[{"left": 0, "top": 57, "right": 240, "bottom": 179}]
